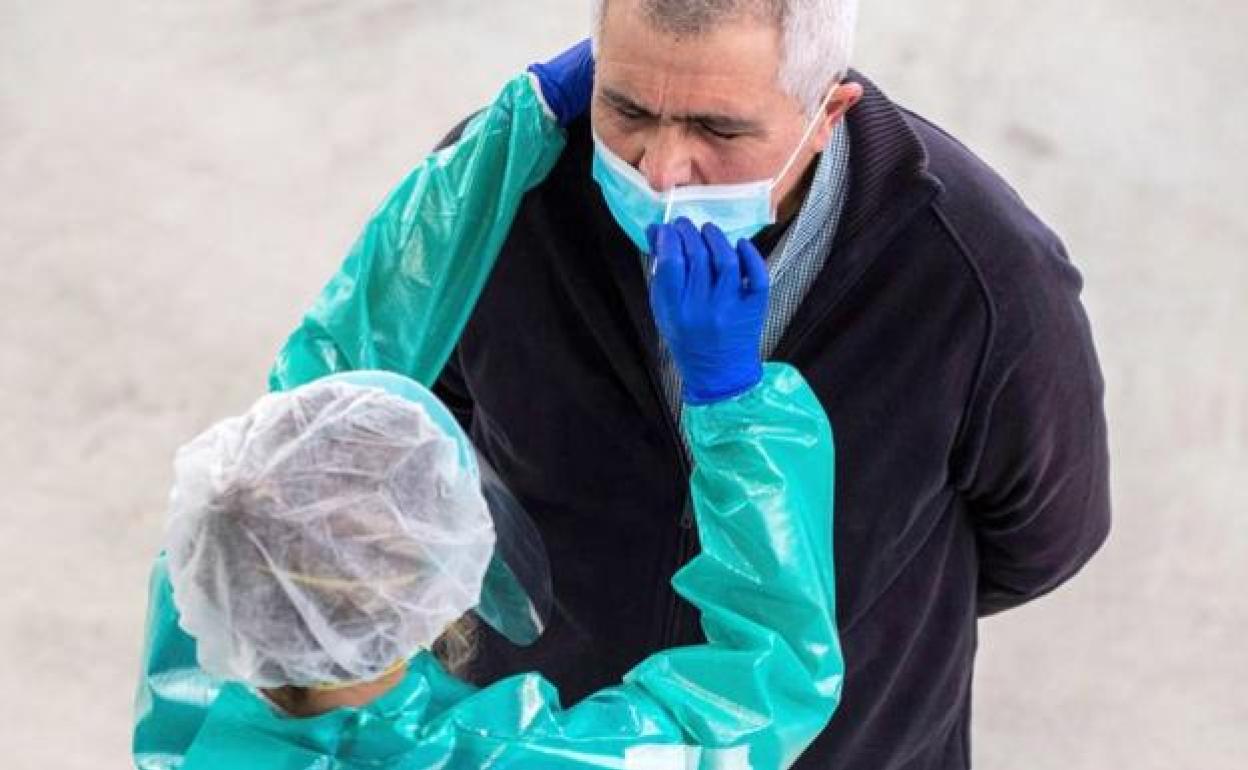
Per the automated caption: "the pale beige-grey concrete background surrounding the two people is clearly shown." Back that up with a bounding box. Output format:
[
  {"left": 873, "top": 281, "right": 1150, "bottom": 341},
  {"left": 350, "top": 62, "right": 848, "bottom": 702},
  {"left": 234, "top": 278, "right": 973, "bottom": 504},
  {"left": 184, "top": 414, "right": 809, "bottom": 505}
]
[{"left": 0, "top": 0, "right": 1248, "bottom": 770}]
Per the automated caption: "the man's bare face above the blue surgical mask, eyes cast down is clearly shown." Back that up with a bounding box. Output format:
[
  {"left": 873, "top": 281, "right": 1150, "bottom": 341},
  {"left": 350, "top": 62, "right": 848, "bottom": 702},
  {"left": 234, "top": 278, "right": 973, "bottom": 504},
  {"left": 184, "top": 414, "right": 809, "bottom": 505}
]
[{"left": 590, "top": 0, "right": 831, "bottom": 206}]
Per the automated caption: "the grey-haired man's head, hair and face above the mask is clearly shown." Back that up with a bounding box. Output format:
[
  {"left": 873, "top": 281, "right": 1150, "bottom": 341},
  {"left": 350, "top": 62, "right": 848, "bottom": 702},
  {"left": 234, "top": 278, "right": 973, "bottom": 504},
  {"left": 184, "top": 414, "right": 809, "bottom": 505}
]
[{"left": 592, "top": 0, "right": 862, "bottom": 219}]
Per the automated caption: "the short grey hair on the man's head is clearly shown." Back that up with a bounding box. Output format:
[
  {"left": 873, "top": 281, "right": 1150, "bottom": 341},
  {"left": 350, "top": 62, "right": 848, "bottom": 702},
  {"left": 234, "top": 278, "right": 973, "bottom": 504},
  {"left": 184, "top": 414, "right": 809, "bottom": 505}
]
[{"left": 592, "top": 0, "right": 857, "bottom": 116}]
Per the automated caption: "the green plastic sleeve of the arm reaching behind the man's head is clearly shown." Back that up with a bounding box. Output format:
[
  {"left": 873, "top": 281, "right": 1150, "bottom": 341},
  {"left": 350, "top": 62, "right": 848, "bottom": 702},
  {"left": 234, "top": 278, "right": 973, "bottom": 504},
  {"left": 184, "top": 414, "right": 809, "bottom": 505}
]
[{"left": 270, "top": 66, "right": 565, "bottom": 391}]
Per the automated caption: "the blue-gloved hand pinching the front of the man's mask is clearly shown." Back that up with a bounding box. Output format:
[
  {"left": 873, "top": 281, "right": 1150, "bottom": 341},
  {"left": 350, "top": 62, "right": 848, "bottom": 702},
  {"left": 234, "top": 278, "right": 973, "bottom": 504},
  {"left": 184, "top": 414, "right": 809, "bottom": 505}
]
[{"left": 648, "top": 217, "right": 770, "bottom": 404}]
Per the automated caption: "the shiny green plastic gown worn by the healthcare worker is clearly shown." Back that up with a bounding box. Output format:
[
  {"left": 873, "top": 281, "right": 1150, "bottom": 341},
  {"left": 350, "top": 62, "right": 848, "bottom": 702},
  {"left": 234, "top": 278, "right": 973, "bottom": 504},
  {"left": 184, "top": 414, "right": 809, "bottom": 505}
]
[{"left": 134, "top": 70, "right": 844, "bottom": 770}]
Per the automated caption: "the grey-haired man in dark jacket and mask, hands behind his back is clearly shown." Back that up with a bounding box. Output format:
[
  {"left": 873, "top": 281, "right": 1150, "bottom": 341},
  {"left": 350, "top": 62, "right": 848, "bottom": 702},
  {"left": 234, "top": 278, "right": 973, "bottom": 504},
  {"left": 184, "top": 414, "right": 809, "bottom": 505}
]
[{"left": 275, "top": 0, "right": 1109, "bottom": 770}]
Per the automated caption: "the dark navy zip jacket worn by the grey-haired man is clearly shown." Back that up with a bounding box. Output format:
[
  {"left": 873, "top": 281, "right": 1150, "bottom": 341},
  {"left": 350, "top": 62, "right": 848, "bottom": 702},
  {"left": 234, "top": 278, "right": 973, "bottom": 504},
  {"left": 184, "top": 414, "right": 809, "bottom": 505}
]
[{"left": 438, "top": 75, "right": 1109, "bottom": 770}]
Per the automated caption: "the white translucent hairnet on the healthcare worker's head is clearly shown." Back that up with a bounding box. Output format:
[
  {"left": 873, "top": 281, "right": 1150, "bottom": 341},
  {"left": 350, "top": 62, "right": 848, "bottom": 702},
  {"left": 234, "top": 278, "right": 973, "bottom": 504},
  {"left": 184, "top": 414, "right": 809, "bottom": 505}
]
[{"left": 166, "top": 383, "right": 494, "bottom": 688}]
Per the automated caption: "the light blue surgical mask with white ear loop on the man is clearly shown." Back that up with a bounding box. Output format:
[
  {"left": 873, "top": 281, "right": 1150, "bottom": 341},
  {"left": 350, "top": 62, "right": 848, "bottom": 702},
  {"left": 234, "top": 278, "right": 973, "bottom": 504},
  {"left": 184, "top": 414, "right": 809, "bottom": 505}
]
[{"left": 594, "top": 91, "right": 832, "bottom": 252}]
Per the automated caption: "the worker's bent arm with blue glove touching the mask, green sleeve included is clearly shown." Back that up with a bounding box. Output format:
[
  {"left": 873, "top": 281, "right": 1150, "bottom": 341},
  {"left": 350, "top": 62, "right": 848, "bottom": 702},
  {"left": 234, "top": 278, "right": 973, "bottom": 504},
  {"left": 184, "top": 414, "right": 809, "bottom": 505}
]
[{"left": 436, "top": 220, "right": 844, "bottom": 769}]
